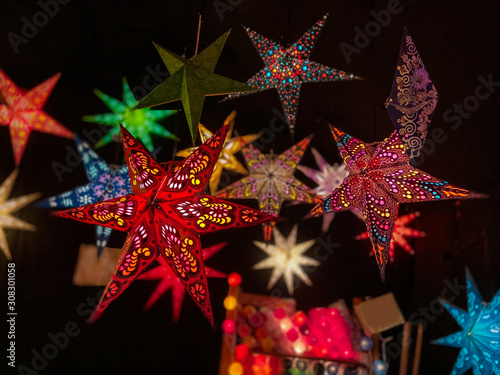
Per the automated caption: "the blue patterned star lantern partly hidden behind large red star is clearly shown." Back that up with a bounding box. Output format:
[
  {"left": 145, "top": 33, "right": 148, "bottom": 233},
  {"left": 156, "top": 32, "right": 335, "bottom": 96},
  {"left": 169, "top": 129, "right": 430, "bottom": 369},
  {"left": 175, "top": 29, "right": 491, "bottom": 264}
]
[{"left": 37, "top": 137, "right": 132, "bottom": 256}]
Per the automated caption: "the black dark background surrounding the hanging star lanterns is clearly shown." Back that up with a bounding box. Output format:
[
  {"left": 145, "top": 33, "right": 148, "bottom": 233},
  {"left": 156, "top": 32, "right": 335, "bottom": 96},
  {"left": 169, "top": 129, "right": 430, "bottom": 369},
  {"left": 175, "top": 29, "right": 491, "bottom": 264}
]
[{"left": 0, "top": 0, "right": 500, "bottom": 374}]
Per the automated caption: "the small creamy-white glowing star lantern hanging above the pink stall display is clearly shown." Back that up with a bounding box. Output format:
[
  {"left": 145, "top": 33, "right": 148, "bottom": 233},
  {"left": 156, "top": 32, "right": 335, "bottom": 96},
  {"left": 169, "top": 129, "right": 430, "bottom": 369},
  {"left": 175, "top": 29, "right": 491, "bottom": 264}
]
[{"left": 253, "top": 224, "right": 321, "bottom": 295}]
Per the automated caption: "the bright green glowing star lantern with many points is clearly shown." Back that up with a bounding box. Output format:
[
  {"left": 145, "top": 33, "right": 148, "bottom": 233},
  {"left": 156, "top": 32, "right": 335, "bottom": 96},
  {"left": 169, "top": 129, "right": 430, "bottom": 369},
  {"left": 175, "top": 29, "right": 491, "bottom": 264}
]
[{"left": 83, "top": 78, "right": 179, "bottom": 151}]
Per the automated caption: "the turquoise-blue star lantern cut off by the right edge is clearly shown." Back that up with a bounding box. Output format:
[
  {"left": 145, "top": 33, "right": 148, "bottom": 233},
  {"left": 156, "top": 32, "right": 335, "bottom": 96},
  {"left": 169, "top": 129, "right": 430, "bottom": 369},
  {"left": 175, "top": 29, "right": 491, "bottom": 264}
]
[{"left": 432, "top": 269, "right": 500, "bottom": 375}]
